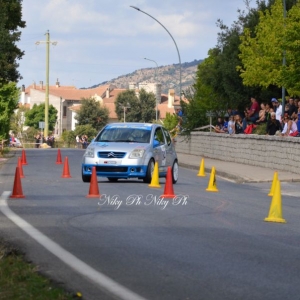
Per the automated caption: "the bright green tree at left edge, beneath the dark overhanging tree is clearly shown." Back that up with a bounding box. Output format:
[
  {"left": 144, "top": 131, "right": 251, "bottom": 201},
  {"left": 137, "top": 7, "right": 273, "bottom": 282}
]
[{"left": 0, "top": 82, "right": 20, "bottom": 140}]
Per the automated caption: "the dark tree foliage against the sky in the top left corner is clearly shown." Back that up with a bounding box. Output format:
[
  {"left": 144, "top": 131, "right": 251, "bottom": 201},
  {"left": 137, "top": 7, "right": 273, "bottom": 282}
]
[{"left": 0, "top": 0, "right": 26, "bottom": 84}]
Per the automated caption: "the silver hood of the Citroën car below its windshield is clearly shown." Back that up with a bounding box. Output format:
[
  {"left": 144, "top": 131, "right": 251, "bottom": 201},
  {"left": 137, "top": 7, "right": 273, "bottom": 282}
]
[{"left": 89, "top": 142, "right": 150, "bottom": 152}]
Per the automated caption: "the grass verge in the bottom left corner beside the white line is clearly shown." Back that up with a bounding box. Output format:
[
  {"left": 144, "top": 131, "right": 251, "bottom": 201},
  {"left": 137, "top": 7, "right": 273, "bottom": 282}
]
[{"left": 0, "top": 240, "right": 82, "bottom": 300}]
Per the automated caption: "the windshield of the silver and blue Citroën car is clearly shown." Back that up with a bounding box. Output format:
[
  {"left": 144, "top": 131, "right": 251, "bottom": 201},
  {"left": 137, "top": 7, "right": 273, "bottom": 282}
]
[{"left": 95, "top": 127, "right": 151, "bottom": 143}]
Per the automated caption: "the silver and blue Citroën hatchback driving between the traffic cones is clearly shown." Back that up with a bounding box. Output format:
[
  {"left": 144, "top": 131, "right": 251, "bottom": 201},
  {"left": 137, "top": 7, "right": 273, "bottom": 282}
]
[{"left": 82, "top": 123, "right": 179, "bottom": 183}]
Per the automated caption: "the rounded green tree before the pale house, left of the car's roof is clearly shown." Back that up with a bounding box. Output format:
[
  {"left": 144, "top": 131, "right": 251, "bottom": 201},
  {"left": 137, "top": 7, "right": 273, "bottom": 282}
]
[{"left": 75, "top": 98, "right": 109, "bottom": 131}]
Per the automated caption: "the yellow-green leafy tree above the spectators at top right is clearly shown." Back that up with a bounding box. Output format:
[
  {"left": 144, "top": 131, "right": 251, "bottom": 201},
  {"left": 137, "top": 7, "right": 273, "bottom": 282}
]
[{"left": 238, "top": 0, "right": 300, "bottom": 95}]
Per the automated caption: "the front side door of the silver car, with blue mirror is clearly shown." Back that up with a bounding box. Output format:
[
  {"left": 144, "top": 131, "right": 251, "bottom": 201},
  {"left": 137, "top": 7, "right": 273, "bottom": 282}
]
[{"left": 153, "top": 127, "right": 167, "bottom": 172}]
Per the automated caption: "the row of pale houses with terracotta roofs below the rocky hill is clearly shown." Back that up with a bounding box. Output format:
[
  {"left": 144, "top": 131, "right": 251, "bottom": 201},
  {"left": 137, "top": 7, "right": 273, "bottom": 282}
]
[{"left": 20, "top": 80, "right": 180, "bottom": 136}]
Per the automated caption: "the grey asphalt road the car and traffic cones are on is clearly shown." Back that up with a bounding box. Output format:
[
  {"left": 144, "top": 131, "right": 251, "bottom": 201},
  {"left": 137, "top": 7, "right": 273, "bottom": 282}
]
[{"left": 0, "top": 149, "right": 300, "bottom": 300}]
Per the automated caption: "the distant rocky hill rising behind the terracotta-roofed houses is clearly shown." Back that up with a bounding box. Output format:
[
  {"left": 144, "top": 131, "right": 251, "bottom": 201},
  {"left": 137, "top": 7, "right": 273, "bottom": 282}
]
[{"left": 91, "top": 59, "right": 203, "bottom": 95}]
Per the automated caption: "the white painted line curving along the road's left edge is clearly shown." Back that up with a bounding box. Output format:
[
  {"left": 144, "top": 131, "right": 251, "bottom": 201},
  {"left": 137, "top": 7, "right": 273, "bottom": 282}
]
[{"left": 0, "top": 191, "right": 146, "bottom": 300}]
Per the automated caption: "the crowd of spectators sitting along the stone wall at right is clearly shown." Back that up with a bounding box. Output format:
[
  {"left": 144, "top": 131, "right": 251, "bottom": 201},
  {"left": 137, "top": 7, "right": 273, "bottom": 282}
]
[{"left": 215, "top": 97, "right": 300, "bottom": 136}]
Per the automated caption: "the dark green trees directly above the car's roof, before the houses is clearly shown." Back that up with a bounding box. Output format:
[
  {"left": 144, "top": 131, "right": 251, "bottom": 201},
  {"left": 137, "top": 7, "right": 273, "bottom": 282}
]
[{"left": 115, "top": 89, "right": 156, "bottom": 122}]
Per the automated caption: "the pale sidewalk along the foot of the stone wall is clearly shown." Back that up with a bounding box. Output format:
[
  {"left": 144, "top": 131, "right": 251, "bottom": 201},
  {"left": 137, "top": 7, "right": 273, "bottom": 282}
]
[{"left": 177, "top": 153, "right": 300, "bottom": 183}]
